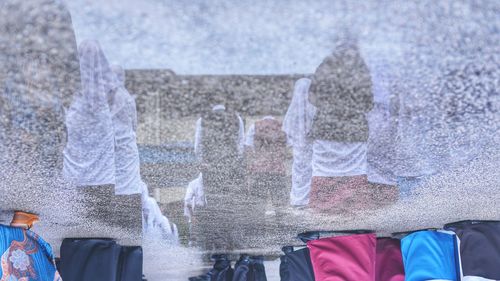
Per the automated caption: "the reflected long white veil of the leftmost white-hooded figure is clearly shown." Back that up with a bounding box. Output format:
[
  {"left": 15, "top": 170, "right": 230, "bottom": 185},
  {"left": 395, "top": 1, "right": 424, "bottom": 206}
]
[{"left": 63, "top": 41, "right": 115, "bottom": 186}]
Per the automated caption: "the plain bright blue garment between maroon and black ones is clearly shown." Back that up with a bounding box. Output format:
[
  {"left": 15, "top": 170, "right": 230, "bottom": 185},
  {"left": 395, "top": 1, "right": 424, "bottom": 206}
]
[{"left": 401, "top": 230, "right": 460, "bottom": 281}]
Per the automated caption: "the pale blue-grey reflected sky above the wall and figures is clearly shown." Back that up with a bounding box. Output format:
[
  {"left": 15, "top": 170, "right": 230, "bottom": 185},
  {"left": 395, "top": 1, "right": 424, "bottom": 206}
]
[{"left": 60, "top": 0, "right": 500, "bottom": 74}]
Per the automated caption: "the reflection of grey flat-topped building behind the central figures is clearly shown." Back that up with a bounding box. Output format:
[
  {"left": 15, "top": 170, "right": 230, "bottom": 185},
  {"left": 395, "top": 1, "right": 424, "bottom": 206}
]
[{"left": 126, "top": 70, "right": 303, "bottom": 145}]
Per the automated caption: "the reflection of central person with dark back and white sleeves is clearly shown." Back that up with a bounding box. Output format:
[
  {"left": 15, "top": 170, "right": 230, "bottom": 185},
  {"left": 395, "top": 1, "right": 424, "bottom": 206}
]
[{"left": 191, "top": 96, "right": 244, "bottom": 251}]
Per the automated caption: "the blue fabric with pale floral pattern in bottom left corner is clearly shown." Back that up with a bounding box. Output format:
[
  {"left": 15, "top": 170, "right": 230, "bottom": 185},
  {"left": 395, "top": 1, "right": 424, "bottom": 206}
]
[{"left": 0, "top": 225, "right": 61, "bottom": 281}]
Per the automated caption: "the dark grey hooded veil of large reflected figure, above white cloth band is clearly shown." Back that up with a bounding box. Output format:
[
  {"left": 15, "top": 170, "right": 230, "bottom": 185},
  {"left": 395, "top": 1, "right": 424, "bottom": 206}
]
[{"left": 309, "top": 38, "right": 373, "bottom": 143}]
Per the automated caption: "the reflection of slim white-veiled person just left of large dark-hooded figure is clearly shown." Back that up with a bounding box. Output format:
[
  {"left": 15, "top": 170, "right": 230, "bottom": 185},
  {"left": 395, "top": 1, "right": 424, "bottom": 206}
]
[{"left": 283, "top": 78, "right": 316, "bottom": 206}]
